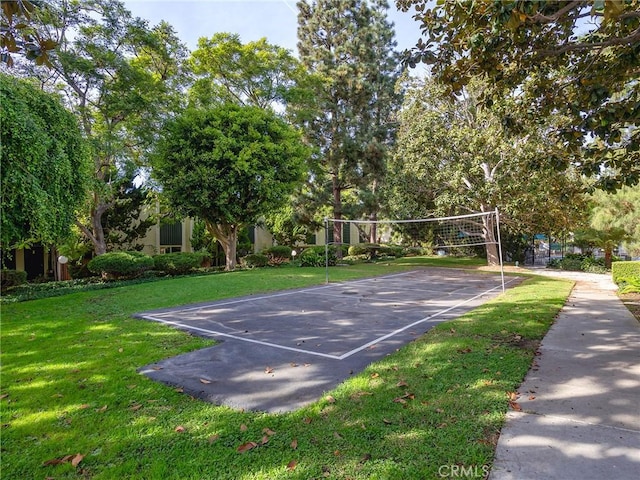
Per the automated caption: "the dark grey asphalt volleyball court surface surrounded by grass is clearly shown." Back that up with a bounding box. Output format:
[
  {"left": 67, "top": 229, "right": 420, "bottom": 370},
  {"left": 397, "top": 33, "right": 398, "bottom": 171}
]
[{"left": 135, "top": 269, "right": 518, "bottom": 412}]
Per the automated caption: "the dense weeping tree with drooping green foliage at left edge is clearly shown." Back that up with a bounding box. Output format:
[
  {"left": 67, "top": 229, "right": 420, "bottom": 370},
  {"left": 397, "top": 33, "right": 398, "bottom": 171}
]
[{"left": 0, "top": 74, "right": 90, "bottom": 248}]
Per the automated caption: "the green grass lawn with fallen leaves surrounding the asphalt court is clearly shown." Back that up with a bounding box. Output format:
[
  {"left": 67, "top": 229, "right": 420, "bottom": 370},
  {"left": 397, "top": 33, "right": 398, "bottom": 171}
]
[{"left": 0, "top": 259, "right": 572, "bottom": 480}]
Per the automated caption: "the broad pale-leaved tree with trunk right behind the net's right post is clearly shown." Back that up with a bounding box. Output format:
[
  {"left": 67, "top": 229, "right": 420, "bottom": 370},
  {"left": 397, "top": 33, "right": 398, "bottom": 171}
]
[{"left": 388, "top": 80, "right": 582, "bottom": 264}]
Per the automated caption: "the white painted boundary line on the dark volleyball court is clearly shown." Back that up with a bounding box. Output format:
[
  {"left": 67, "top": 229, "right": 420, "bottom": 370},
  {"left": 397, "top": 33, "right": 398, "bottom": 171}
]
[{"left": 138, "top": 275, "right": 516, "bottom": 360}]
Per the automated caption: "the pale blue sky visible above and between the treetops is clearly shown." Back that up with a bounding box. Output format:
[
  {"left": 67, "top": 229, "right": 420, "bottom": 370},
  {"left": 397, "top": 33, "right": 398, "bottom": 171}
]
[{"left": 124, "top": 0, "right": 428, "bottom": 55}]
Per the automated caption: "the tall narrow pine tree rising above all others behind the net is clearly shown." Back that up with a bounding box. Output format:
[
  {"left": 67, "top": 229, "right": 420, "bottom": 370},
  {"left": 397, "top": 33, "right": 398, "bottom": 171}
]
[{"left": 298, "top": 0, "right": 400, "bottom": 248}]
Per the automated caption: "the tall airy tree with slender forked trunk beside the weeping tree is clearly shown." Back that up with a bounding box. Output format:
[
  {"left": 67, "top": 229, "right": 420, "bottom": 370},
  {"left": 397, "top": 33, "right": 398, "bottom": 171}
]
[{"left": 25, "top": 0, "right": 186, "bottom": 255}]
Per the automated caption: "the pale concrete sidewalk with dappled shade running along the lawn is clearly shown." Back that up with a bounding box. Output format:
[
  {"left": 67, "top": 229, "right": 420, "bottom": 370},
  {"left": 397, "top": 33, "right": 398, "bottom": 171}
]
[{"left": 489, "top": 271, "right": 640, "bottom": 480}]
